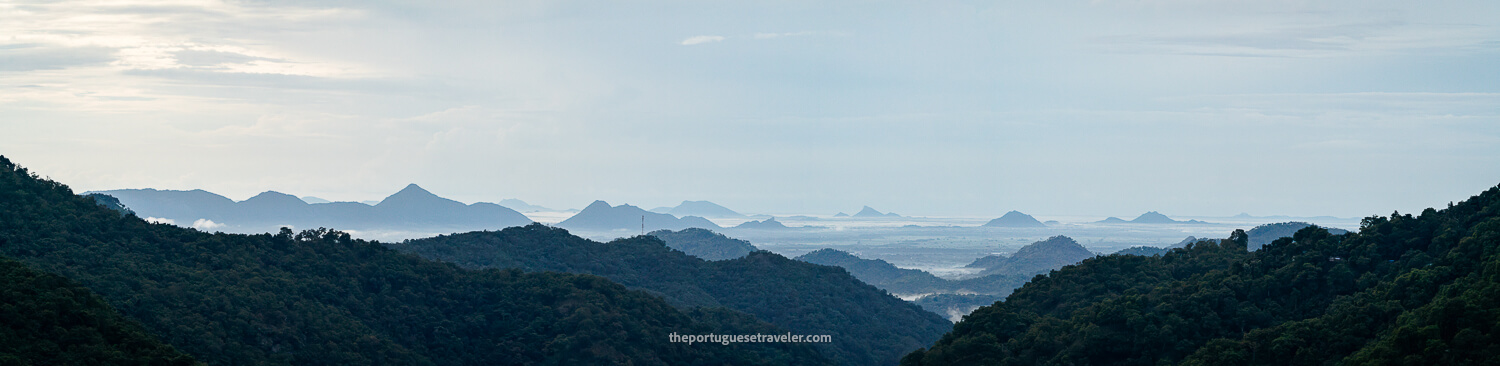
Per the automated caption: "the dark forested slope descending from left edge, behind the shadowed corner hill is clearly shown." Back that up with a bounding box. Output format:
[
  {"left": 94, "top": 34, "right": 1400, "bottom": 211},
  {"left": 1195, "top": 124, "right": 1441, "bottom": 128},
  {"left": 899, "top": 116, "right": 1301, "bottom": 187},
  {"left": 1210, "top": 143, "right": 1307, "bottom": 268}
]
[{"left": 0, "top": 158, "right": 827, "bottom": 365}]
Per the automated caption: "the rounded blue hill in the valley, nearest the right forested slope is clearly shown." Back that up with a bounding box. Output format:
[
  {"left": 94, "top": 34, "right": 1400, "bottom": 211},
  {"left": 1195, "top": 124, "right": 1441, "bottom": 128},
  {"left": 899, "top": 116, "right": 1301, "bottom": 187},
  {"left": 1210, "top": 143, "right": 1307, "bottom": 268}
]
[{"left": 965, "top": 236, "right": 1094, "bottom": 276}]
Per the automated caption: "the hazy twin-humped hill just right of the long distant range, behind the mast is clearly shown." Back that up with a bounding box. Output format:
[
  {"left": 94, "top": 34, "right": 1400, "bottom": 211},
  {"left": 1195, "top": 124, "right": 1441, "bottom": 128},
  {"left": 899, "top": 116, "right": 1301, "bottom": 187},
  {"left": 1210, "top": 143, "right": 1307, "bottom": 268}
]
[{"left": 558, "top": 201, "right": 720, "bottom": 231}]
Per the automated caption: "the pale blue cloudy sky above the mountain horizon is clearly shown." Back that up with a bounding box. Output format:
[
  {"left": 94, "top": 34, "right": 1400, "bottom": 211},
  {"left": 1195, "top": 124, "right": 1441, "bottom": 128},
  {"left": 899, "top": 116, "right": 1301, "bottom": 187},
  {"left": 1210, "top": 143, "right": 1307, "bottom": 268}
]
[{"left": 0, "top": 0, "right": 1500, "bottom": 218}]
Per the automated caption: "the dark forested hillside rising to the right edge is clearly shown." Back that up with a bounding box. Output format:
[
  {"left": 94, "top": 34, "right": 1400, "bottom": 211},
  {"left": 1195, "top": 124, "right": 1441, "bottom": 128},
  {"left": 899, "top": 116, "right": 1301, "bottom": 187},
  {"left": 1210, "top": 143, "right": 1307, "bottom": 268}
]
[{"left": 903, "top": 188, "right": 1500, "bottom": 365}]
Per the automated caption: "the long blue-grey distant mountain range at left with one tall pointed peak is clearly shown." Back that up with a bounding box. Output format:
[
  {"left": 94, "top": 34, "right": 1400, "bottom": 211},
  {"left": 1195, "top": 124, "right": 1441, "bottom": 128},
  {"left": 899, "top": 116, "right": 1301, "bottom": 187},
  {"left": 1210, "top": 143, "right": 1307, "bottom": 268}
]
[{"left": 89, "top": 185, "right": 531, "bottom": 233}]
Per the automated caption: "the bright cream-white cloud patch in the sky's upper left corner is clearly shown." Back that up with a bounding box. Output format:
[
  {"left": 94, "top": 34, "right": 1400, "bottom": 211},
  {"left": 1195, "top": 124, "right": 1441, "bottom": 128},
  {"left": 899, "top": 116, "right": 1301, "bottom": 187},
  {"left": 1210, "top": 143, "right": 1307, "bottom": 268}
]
[{"left": 0, "top": 0, "right": 363, "bottom": 77}]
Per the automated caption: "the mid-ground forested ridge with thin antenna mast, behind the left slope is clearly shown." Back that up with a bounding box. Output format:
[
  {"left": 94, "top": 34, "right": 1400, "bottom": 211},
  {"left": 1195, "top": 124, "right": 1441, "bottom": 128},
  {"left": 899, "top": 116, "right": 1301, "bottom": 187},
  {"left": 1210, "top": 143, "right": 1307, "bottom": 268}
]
[{"left": 392, "top": 228, "right": 950, "bottom": 365}]
